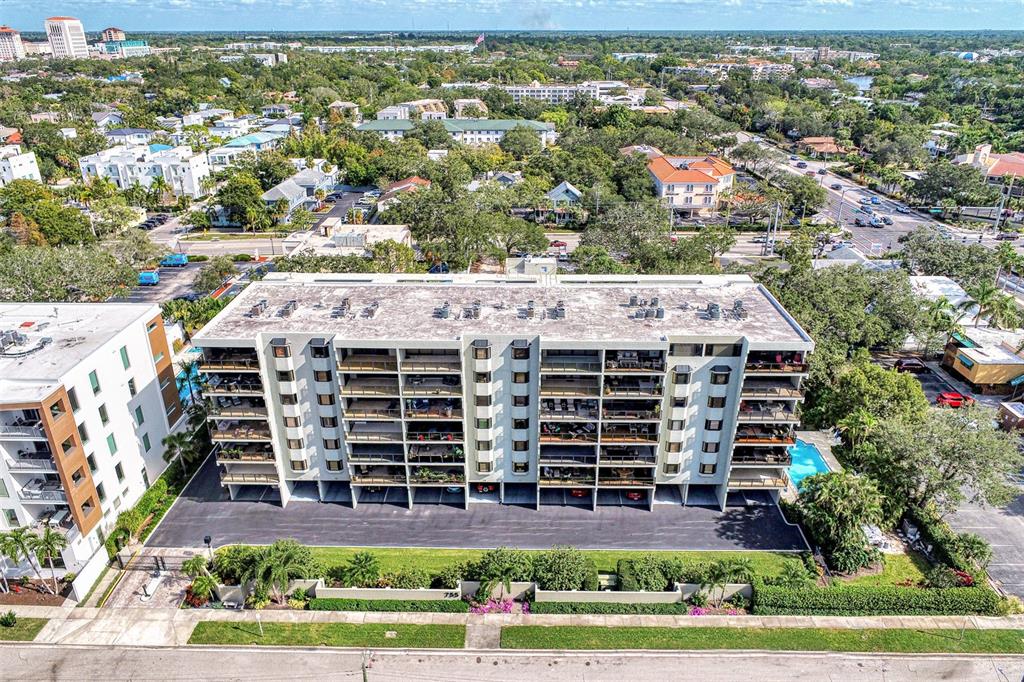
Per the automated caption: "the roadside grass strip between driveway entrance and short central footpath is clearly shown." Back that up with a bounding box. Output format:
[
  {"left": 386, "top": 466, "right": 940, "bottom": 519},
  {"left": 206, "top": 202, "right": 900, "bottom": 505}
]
[{"left": 188, "top": 621, "right": 466, "bottom": 649}]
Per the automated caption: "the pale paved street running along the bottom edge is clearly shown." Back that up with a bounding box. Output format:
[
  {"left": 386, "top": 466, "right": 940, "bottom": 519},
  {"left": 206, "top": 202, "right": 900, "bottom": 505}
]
[{"left": 0, "top": 644, "right": 1024, "bottom": 682}]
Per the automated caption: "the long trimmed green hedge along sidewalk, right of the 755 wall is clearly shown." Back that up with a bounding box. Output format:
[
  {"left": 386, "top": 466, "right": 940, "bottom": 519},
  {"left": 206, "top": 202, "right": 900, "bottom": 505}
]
[{"left": 753, "top": 583, "right": 999, "bottom": 615}]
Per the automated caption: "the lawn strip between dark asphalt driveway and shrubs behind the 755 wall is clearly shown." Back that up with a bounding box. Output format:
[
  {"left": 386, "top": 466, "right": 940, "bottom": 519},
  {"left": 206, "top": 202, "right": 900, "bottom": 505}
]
[{"left": 310, "top": 547, "right": 800, "bottom": 576}]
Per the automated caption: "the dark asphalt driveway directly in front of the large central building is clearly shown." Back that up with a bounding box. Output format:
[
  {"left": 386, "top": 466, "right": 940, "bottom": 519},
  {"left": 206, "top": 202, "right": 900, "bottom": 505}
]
[{"left": 148, "top": 459, "right": 807, "bottom": 551}]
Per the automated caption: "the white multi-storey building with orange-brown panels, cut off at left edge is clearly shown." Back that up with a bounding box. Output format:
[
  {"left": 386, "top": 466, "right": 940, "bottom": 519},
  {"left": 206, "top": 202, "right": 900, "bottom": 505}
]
[{"left": 0, "top": 303, "right": 182, "bottom": 598}]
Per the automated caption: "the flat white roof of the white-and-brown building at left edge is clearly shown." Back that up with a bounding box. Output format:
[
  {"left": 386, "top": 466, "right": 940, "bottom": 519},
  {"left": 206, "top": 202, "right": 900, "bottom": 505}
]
[{"left": 0, "top": 303, "right": 157, "bottom": 403}]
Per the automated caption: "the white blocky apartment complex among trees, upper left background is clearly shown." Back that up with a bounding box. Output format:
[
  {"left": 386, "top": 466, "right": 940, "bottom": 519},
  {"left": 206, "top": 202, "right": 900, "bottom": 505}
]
[{"left": 78, "top": 145, "right": 210, "bottom": 199}]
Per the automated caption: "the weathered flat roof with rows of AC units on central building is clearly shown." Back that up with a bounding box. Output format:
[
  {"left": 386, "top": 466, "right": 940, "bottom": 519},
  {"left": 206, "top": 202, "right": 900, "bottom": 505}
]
[{"left": 194, "top": 273, "right": 811, "bottom": 347}]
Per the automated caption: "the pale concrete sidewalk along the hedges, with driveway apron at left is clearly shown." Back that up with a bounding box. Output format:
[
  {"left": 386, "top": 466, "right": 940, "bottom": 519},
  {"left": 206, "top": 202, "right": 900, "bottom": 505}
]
[{"left": 13, "top": 606, "right": 1024, "bottom": 646}]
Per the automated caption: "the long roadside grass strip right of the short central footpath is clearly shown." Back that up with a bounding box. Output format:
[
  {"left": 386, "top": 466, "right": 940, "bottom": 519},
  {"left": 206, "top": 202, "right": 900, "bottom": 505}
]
[{"left": 502, "top": 626, "right": 1024, "bottom": 653}]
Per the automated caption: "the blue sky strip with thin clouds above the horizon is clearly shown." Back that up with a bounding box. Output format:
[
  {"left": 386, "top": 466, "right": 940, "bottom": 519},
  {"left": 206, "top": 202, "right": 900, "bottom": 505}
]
[{"left": 6, "top": 0, "right": 1024, "bottom": 32}]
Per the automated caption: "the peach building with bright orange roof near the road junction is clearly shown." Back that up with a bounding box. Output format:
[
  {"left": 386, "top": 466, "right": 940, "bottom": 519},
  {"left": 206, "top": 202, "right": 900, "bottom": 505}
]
[{"left": 647, "top": 156, "right": 736, "bottom": 217}]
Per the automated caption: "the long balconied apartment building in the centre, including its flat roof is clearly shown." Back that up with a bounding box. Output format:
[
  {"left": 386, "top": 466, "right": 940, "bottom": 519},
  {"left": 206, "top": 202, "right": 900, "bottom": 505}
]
[{"left": 194, "top": 273, "right": 813, "bottom": 508}]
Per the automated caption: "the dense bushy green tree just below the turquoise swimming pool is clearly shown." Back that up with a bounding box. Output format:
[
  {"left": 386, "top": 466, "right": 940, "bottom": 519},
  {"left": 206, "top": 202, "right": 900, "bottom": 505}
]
[{"left": 797, "top": 471, "right": 883, "bottom": 572}]
